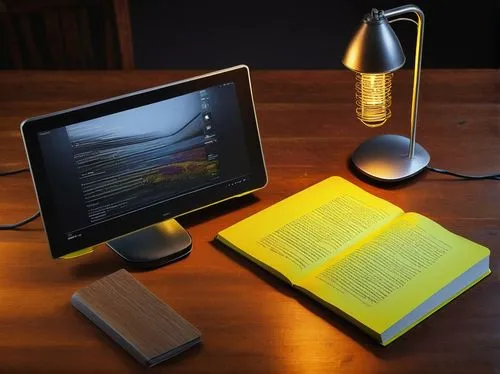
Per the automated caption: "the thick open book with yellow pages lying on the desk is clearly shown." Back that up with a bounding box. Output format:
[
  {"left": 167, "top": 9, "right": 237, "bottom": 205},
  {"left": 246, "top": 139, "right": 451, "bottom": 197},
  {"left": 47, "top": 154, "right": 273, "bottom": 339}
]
[{"left": 216, "top": 177, "right": 491, "bottom": 345}]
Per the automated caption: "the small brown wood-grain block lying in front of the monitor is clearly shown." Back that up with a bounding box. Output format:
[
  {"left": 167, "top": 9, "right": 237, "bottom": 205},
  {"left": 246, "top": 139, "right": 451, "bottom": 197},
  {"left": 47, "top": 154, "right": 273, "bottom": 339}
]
[{"left": 71, "top": 269, "right": 201, "bottom": 366}]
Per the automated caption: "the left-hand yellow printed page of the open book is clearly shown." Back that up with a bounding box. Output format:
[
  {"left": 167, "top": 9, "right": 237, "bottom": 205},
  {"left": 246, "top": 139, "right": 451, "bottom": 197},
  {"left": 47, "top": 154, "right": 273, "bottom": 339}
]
[{"left": 217, "top": 177, "right": 403, "bottom": 283}]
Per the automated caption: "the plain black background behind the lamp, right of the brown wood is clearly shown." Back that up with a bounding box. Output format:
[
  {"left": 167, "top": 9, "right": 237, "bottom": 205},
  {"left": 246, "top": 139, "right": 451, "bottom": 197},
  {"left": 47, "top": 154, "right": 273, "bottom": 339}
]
[{"left": 130, "top": 0, "right": 500, "bottom": 69}]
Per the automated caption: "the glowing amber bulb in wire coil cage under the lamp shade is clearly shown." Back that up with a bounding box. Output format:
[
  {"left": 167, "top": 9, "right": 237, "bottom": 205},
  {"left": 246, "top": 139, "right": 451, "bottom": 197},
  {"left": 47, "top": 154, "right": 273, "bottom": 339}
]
[{"left": 356, "top": 73, "right": 392, "bottom": 127}]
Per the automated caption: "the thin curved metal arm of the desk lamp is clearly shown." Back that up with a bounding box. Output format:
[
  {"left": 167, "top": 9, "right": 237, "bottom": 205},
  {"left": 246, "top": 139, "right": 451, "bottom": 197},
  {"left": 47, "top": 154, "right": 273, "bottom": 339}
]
[{"left": 384, "top": 5, "right": 425, "bottom": 158}]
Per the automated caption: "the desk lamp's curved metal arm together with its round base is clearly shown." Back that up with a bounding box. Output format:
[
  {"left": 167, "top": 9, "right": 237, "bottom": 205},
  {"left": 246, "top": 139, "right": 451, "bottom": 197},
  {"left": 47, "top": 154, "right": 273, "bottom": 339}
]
[{"left": 352, "top": 5, "right": 430, "bottom": 182}]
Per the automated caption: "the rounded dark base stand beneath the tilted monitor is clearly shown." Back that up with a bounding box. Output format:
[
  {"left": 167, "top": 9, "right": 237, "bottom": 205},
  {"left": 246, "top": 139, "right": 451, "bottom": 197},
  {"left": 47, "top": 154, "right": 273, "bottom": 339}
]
[{"left": 107, "top": 219, "right": 192, "bottom": 268}]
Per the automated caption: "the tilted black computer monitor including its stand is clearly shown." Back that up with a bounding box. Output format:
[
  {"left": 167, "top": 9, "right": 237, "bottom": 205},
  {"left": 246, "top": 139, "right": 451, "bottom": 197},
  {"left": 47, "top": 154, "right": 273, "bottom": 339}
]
[{"left": 21, "top": 65, "right": 267, "bottom": 267}]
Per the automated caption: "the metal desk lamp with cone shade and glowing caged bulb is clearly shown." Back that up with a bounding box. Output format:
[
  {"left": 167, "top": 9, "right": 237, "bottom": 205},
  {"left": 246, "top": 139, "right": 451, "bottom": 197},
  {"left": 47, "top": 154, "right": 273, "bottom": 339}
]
[{"left": 342, "top": 5, "right": 430, "bottom": 182}]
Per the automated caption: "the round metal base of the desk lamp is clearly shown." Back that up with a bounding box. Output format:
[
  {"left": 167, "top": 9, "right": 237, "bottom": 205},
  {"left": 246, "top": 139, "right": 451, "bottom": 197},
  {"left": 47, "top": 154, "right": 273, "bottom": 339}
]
[{"left": 352, "top": 135, "right": 431, "bottom": 182}]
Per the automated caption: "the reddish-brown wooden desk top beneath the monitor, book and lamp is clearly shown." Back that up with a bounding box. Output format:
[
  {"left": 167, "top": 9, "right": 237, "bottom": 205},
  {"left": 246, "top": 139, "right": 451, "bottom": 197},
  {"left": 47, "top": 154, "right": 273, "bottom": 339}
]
[{"left": 0, "top": 70, "right": 500, "bottom": 374}]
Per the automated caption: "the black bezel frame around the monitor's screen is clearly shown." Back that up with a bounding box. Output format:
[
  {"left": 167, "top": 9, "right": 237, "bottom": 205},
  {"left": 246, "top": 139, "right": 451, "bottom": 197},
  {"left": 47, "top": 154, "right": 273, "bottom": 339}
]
[{"left": 20, "top": 65, "right": 267, "bottom": 258}]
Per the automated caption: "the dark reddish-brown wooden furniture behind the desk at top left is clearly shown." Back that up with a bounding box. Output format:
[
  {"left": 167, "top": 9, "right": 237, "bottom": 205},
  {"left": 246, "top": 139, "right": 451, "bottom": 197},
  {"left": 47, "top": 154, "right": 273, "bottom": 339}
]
[{"left": 0, "top": 0, "right": 134, "bottom": 69}]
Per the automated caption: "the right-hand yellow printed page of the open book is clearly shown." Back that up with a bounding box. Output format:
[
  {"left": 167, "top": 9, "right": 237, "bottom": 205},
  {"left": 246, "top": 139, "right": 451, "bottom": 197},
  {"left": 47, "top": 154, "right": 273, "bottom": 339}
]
[{"left": 299, "top": 213, "right": 489, "bottom": 333}]
